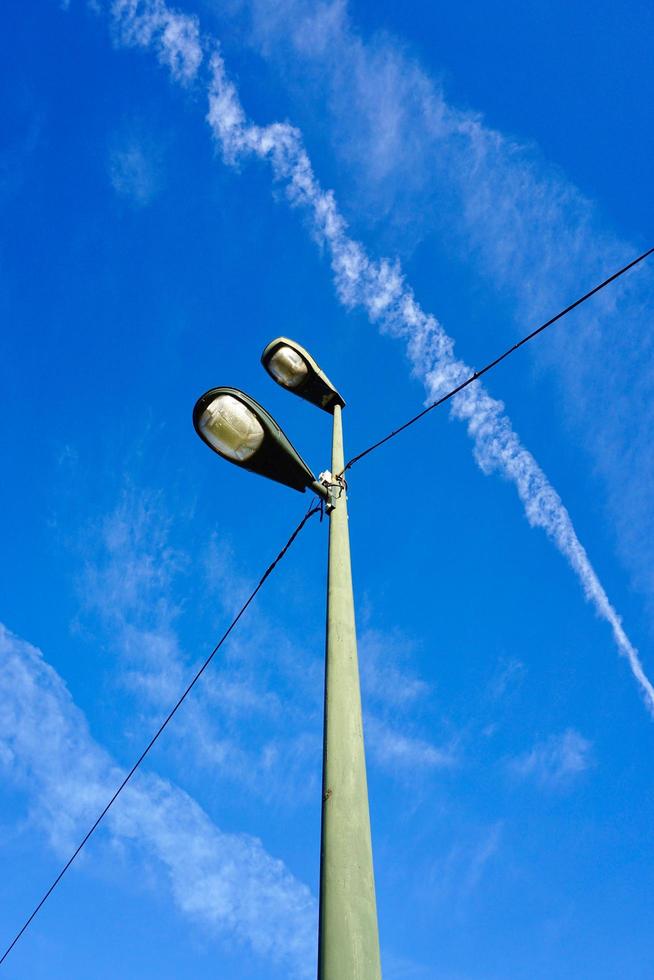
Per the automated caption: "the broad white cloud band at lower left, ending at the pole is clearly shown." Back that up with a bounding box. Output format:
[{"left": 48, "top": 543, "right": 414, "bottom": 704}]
[{"left": 0, "top": 625, "right": 317, "bottom": 977}]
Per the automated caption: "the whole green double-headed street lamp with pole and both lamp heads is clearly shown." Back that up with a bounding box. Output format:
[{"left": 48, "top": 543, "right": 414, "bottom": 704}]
[{"left": 193, "top": 337, "right": 381, "bottom": 980}]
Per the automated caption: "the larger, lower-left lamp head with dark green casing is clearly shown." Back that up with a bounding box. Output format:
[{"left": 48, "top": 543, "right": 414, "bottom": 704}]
[{"left": 193, "top": 388, "right": 316, "bottom": 493}]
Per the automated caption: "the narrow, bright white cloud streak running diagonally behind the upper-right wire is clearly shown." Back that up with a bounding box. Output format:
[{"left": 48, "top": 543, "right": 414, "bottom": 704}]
[{"left": 98, "top": 0, "right": 654, "bottom": 714}]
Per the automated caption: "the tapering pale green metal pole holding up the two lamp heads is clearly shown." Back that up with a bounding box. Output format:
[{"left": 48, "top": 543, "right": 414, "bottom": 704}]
[{"left": 318, "top": 405, "right": 381, "bottom": 980}]
